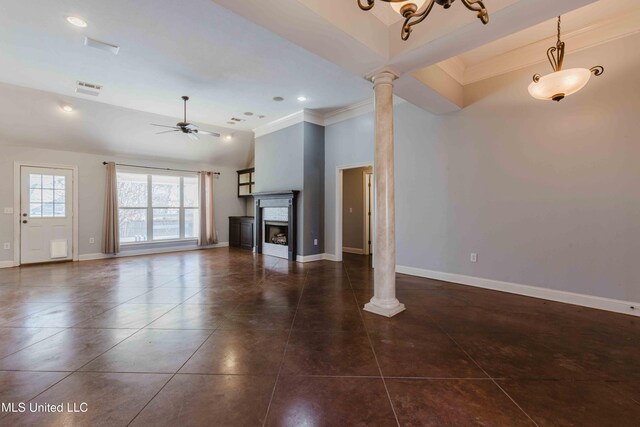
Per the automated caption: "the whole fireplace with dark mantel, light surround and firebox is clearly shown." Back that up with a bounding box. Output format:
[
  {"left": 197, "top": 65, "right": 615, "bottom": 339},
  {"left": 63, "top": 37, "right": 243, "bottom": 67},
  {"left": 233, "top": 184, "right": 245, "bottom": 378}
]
[{"left": 253, "top": 191, "right": 298, "bottom": 261}]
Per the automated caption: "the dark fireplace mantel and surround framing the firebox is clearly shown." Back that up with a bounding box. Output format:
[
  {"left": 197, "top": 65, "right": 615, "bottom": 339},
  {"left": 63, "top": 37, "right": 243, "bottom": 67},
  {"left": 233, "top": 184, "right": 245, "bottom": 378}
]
[{"left": 252, "top": 190, "right": 299, "bottom": 261}]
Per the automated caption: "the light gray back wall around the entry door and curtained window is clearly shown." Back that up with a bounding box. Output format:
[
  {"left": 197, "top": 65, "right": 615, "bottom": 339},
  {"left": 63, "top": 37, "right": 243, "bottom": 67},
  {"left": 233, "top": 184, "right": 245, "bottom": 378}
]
[{"left": 0, "top": 145, "right": 245, "bottom": 261}]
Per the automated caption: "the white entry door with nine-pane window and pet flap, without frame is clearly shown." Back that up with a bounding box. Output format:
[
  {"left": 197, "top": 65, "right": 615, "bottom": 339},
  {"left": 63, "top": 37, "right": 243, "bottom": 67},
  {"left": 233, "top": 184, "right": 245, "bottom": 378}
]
[{"left": 20, "top": 166, "right": 73, "bottom": 264}]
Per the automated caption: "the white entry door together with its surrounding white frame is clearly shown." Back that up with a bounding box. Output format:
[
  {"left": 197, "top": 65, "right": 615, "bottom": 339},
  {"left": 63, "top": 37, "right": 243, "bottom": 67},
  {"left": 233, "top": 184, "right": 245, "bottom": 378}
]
[{"left": 13, "top": 162, "right": 78, "bottom": 265}]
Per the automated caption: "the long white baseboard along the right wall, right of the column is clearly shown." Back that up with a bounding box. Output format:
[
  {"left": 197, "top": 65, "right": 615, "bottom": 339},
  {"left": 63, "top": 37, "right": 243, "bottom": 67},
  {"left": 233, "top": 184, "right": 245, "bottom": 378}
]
[{"left": 396, "top": 265, "right": 640, "bottom": 317}]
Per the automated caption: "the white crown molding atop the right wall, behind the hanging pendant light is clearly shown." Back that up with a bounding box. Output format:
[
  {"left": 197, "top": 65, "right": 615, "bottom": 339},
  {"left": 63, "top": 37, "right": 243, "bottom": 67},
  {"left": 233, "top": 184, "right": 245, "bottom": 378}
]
[{"left": 437, "top": 9, "right": 640, "bottom": 86}]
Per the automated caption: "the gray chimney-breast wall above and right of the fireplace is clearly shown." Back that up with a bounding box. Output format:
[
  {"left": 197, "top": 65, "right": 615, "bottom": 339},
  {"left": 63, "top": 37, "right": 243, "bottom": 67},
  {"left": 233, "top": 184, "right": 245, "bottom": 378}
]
[{"left": 255, "top": 122, "right": 324, "bottom": 255}]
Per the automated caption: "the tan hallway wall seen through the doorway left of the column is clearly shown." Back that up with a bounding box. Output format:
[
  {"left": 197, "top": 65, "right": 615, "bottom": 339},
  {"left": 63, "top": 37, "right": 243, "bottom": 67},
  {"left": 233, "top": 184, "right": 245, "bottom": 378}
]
[{"left": 342, "top": 168, "right": 371, "bottom": 249}]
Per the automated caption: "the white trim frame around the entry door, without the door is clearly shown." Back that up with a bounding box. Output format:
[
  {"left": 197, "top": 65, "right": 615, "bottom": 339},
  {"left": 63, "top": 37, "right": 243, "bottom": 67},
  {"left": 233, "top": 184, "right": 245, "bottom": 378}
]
[{"left": 13, "top": 161, "right": 79, "bottom": 267}]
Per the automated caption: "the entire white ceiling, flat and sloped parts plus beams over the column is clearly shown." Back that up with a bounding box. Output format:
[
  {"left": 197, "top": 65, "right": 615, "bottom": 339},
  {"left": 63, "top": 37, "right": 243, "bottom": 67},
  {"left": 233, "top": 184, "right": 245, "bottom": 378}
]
[{"left": 0, "top": 0, "right": 620, "bottom": 166}]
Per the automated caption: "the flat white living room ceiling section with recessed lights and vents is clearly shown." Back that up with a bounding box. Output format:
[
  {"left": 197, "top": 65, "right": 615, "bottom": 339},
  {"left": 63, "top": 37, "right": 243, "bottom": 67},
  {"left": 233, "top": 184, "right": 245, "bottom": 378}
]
[{"left": 0, "top": 0, "right": 371, "bottom": 130}]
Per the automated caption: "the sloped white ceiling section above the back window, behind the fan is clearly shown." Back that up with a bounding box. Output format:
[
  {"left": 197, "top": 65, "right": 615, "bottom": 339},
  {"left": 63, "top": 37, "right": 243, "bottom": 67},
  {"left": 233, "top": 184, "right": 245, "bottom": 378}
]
[{"left": 0, "top": 83, "right": 253, "bottom": 167}]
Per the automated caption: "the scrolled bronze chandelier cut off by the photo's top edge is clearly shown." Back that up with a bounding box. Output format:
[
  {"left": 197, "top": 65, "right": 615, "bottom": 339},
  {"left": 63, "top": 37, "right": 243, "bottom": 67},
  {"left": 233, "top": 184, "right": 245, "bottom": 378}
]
[{"left": 358, "top": 0, "right": 489, "bottom": 40}]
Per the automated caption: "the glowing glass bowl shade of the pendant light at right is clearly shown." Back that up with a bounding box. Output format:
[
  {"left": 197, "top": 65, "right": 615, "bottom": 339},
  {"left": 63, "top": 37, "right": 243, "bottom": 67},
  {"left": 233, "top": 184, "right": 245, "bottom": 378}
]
[{"left": 529, "top": 68, "right": 591, "bottom": 101}]
